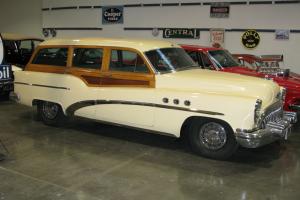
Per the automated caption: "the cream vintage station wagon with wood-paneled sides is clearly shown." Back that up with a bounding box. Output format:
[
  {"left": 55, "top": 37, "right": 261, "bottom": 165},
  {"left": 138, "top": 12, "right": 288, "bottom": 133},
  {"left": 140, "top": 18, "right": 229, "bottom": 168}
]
[{"left": 13, "top": 38, "right": 297, "bottom": 159}]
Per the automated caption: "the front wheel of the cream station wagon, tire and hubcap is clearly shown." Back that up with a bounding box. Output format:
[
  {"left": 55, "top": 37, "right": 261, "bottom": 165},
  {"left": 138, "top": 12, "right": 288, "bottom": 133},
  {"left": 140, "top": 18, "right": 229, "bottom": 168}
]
[{"left": 189, "top": 119, "right": 238, "bottom": 160}]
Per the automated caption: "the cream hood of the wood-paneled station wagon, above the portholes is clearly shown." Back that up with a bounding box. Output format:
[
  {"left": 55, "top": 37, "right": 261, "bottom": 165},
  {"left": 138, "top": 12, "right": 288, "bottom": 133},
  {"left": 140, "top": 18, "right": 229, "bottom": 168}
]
[{"left": 156, "top": 69, "right": 280, "bottom": 105}]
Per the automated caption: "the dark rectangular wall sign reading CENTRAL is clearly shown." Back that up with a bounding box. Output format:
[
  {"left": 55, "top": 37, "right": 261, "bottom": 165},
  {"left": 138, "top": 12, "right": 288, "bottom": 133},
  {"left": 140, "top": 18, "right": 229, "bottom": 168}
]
[{"left": 163, "top": 28, "right": 200, "bottom": 39}]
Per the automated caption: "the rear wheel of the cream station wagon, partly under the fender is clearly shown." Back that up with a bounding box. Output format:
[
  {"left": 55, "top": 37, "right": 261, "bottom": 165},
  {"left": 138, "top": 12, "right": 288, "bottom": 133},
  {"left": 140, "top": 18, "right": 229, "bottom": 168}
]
[{"left": 37, "top": 101, "right": 66, "bottom": 126}]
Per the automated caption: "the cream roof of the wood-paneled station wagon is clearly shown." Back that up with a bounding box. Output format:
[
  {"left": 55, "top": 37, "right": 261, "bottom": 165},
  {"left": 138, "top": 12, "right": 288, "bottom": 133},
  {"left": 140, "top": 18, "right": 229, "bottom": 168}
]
[{"left": 40, "top": 38, "right": 180, "bottom": 52}]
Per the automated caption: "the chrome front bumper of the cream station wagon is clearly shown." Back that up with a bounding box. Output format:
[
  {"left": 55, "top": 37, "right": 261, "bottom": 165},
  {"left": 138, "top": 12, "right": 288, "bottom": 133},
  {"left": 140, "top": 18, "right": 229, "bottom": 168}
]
[{"left": 235, "top": 112, "right": 297, "bottom": 148}]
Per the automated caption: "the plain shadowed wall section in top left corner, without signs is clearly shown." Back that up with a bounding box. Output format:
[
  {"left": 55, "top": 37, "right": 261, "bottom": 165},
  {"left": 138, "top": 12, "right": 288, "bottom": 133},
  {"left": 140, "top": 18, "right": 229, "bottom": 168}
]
[{"left": 0, "top": 0, "right": 42, "bottom": 37}]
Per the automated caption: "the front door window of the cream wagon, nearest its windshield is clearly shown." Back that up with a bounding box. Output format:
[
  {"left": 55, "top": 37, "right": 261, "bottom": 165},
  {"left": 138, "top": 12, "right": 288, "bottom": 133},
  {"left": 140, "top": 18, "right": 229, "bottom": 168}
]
[{"left": 109, "top": 50, "right": 149, "bottom": 73}]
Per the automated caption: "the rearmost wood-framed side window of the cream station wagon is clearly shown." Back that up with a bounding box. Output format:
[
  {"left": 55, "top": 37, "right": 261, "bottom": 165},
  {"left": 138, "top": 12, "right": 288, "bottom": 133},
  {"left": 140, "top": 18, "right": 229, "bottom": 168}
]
[{"left": 32, "top": 48, "right": 68, "bottom": 66}]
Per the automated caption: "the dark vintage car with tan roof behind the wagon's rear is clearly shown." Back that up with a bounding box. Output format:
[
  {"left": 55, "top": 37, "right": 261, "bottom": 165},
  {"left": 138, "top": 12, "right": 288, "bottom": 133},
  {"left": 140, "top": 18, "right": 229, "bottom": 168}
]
[{"left": 1, "top": 33, "right": 43, "bottom": 69}]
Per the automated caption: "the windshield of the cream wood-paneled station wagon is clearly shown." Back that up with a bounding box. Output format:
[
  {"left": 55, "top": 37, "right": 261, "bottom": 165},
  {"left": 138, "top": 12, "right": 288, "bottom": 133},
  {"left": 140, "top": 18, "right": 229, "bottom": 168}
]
[{"left": 145, "top": 48, "right": 198, "bottom": 73}]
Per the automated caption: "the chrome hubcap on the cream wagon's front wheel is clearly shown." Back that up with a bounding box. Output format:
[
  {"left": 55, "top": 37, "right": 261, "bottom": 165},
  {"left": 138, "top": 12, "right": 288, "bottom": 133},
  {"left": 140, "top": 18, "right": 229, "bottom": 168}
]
[{"left": 199, "top": 122, "right": 227, "bottom": 150}]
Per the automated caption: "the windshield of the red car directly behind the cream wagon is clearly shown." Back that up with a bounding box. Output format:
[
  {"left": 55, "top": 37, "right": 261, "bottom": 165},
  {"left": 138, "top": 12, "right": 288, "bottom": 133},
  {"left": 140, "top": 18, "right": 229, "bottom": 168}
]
[{"left": 208, "top": 49, "right": 240, "bottom": 68}]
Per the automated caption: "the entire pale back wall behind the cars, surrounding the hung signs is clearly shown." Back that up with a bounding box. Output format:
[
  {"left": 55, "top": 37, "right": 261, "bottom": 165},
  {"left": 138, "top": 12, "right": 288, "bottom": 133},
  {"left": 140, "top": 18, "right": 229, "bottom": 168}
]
[{"left": 0, "top": 0, "right": 300, "bottom": 73}]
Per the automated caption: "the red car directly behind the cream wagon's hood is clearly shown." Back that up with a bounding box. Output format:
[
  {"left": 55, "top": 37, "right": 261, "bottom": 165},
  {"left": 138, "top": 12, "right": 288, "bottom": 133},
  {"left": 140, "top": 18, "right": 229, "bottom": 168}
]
[{"left": 181, "top": 45, "right": 300, "bottom": 111}]
